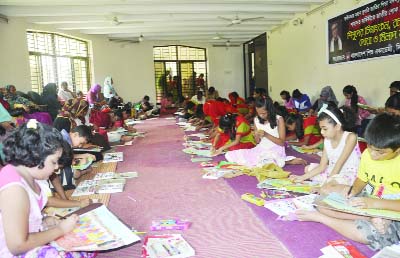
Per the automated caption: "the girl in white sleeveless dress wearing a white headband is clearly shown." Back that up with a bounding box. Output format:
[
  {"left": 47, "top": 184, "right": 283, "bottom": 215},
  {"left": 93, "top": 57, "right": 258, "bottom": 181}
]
[{"left": 290, "top": 105, "right": 361, "bottom": 193}]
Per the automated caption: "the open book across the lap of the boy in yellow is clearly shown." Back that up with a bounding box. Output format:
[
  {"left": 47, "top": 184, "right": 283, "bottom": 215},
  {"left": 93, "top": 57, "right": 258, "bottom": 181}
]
[{"left": 318, "top": 193, "right": 400, "bottom": 221}]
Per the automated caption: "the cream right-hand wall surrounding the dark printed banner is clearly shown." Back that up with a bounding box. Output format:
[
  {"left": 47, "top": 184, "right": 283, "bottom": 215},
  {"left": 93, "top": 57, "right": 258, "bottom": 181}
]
[{"left": 268, "top": 0, "right": 400, "bottom": 106}]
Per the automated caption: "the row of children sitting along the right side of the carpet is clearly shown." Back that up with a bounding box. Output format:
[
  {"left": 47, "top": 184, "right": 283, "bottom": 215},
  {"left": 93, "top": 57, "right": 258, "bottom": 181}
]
[{"left": 180, "top": 81, "right": 400, "bottom": 250}]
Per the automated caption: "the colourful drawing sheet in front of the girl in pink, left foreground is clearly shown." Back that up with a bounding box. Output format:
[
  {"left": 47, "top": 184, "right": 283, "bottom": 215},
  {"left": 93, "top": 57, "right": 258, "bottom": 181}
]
[{"left": 51, "top": 205, "right": 140, "bottom": 251}]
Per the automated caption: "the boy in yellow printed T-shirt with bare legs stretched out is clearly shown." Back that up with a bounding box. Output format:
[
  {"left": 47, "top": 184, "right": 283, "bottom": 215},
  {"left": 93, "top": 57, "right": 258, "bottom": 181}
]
[{"left": 296, "top": 113, "right": 400, "bottom": 250}]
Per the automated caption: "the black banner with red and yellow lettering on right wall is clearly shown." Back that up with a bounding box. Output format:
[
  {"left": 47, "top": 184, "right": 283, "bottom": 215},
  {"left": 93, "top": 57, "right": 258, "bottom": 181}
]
[{"left": 327, "top": 0, "right": 400, "bottom": 64}]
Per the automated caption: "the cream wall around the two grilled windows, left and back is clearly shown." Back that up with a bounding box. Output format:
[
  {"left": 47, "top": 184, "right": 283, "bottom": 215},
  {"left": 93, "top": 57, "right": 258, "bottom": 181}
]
[{"left": 0, "top": 18, "right": 244, "bottom": 101}]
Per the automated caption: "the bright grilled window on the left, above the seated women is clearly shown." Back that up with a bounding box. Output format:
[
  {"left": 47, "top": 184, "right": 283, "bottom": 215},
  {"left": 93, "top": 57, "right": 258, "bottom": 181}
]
[{"left": 26, "top": 31, "right": 90, "bottom": 93}]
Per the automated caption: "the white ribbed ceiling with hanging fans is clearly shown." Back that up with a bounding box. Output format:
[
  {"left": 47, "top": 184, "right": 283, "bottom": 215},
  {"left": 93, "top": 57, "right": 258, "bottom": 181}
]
[{"left": 0, "top": 0, "right": 331, "bottom": 44}]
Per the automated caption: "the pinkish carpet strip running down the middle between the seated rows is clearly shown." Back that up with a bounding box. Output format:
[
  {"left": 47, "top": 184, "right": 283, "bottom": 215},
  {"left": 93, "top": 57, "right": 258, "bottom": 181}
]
[{"left": 98, "top": 118, "right": 293, "bottom": 258}]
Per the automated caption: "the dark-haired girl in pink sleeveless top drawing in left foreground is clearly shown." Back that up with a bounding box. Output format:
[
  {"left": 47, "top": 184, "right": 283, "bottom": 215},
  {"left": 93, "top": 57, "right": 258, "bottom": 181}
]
[{"left": 0, "top": 120, "right": 94, "bottom": 257}]
